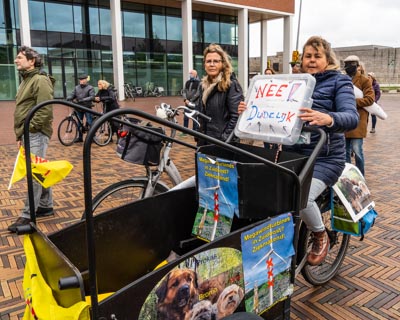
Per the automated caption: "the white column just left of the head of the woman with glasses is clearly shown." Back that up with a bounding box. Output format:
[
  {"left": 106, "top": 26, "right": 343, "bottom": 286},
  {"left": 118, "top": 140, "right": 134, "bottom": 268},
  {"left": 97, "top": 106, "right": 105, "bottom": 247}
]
[{"left": 181, "top": 0, "right": 193, "bottom": 83}]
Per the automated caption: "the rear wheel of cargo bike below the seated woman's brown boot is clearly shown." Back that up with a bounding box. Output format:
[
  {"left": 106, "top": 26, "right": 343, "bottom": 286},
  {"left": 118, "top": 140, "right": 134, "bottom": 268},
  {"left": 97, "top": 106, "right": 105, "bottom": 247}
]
[{"left": 298, "top": 198, "right": 351, "bottom": 286}]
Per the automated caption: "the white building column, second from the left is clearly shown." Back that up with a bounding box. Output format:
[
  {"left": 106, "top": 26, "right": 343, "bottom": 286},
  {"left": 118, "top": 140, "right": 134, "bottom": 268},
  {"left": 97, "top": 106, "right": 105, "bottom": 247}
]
[{"left": 110, "top": 0, "right": 125, "bottom": 100}]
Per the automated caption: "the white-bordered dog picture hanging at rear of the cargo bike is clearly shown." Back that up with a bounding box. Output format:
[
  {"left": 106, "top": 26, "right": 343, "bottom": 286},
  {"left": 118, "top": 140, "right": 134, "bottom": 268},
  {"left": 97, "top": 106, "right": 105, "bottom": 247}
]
[{"left": 333, "top": 163, "right": 375, "bottom": 222}]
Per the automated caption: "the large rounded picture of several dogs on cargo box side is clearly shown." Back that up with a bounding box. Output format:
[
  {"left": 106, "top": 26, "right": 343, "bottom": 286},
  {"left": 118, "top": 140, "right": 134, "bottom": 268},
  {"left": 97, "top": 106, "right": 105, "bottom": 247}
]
[{"left": 138, "top": 248, "right": 244, "bottom": 320}]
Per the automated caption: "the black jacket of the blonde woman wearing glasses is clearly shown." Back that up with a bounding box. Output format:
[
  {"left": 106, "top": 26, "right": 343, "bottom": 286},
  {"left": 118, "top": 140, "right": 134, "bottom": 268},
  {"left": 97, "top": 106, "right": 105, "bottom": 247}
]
[{"left": 197, "top": 76, "right": 244, "bottom": 144}]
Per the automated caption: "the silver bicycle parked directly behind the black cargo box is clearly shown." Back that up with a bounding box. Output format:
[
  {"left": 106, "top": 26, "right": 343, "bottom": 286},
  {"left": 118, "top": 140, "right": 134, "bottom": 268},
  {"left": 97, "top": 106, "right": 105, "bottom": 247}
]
[{"left": 83, "top": 103, "right": 210, "bottom": 218}]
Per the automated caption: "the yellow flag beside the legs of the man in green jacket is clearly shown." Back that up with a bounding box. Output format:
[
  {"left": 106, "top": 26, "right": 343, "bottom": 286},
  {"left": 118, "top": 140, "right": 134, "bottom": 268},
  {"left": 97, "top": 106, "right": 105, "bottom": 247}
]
[{"left": 8, "top": 147, "right": 73, "bottom": 190}]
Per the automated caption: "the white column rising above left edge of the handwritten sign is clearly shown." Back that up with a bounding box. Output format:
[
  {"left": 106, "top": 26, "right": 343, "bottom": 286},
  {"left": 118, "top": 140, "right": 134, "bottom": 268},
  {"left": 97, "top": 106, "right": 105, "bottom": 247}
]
[{"left": 238, "top": 8, "right": 249, "bottom": 95}]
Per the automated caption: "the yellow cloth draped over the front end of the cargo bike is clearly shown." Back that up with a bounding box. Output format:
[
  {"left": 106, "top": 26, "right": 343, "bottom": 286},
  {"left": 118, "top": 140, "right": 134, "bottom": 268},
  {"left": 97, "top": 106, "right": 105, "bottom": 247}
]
[{"left": 23, "top": 235, "right": 90, "bottom": 320}]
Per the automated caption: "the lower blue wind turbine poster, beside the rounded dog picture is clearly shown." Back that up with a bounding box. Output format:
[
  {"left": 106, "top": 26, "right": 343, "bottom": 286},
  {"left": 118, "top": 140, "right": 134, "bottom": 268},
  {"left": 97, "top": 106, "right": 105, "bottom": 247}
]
[{"left": 241, "top": 213, "right": 295, "bottom": 314}]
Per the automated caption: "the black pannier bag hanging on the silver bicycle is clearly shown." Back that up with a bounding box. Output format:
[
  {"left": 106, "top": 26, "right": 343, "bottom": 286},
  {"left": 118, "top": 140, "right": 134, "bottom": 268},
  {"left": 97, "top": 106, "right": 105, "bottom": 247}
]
[{"left": 117, "top": 118, "right": 164, "bottom": 166}]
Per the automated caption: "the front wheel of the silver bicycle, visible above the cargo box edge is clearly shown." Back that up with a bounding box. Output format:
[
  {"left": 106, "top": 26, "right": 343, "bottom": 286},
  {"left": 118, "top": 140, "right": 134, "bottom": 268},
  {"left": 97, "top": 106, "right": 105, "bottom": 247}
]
[{"left": 82, "top": 177, "right": 169, "bottom": 219}]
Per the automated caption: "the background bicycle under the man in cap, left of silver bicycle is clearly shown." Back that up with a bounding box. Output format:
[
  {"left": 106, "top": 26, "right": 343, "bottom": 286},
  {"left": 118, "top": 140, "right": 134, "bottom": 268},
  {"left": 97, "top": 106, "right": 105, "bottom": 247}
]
[{"left": 57, "top": 106, "right": 112, "bottom": 146}]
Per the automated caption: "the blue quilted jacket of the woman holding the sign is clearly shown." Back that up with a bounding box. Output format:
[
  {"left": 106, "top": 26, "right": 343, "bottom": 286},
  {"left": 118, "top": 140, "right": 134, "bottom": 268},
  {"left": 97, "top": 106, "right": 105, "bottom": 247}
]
[{"left": 284, "top": 70, "right": 359, "bottom": 186}]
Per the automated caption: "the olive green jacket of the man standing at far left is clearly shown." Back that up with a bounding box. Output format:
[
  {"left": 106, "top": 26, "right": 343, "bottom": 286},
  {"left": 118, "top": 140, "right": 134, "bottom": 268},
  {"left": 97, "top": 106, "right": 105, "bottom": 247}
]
[{"left": 14, "top": 68, "right": 54, "bottom": 141}]
